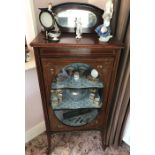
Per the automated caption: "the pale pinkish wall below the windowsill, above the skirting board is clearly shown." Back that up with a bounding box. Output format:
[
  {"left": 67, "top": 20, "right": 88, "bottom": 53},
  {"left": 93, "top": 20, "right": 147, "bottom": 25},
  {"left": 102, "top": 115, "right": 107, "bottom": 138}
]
[{"left": 25, "top": 69, "right": 44, "bottom": 131}]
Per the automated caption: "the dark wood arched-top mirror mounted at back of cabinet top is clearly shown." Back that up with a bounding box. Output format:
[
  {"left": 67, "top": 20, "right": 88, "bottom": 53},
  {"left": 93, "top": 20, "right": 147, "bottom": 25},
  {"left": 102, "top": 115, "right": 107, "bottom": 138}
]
[{"left": 52, "top": 3, "right": 104, "bottom": 33}]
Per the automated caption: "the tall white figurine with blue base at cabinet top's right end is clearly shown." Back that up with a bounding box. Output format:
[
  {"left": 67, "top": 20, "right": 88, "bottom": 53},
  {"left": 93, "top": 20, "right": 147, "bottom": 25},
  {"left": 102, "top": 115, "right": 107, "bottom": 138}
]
[{"left": 95, "top": 0, "right": 113, "bottom": 42}]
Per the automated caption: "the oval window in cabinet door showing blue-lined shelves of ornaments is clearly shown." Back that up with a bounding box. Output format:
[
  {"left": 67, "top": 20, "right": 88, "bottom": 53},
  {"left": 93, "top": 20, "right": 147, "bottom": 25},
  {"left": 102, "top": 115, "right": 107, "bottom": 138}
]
[{"left": 51, "top": 63, "right": 104, "bottom": 126}]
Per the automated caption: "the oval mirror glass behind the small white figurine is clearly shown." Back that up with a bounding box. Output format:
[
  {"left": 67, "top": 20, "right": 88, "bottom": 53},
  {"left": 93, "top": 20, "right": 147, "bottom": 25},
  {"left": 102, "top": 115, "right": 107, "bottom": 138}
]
[{"left": 57, "top": 9, "right": 97, "bottom": 28}]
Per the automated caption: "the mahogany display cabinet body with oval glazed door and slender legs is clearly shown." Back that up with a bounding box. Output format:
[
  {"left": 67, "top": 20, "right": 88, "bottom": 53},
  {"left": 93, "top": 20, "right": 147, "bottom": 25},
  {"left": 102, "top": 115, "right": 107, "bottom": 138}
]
[{"left": 31, "top": 33, "right": 123, "bottom": 154}]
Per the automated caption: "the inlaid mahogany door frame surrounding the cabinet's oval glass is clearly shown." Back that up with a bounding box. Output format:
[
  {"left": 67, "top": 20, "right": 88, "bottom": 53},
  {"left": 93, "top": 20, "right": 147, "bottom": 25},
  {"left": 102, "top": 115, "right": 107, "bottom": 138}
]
[{"left": 41, "top": 56, "right": 116, "bottom": 131}]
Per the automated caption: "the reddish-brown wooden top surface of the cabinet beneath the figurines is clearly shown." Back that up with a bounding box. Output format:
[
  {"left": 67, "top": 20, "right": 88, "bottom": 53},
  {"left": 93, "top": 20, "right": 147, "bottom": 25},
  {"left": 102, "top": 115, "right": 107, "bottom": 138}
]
[{"left": 30, "top": 33, "right": 124, "bottom": 49}]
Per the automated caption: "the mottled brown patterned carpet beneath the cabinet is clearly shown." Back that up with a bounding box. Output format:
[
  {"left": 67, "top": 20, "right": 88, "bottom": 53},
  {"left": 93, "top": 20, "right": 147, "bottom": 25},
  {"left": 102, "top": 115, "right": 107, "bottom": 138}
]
[{"left": 25, "top": 131, "right": 130, "bottom": 155}]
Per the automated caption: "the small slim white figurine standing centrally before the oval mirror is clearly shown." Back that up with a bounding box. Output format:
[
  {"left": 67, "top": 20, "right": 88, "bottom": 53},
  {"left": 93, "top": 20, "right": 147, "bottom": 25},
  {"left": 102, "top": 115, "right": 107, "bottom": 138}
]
[{"left": 75, "top": 17, "right": 82, "bottom": 39}]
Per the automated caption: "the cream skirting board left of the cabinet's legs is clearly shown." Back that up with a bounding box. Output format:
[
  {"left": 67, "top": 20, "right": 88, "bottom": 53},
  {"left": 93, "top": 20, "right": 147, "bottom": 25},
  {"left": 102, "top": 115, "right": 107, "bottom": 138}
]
[{"left": 25, "top": 121, "right": 45, "bottom": 143}]
